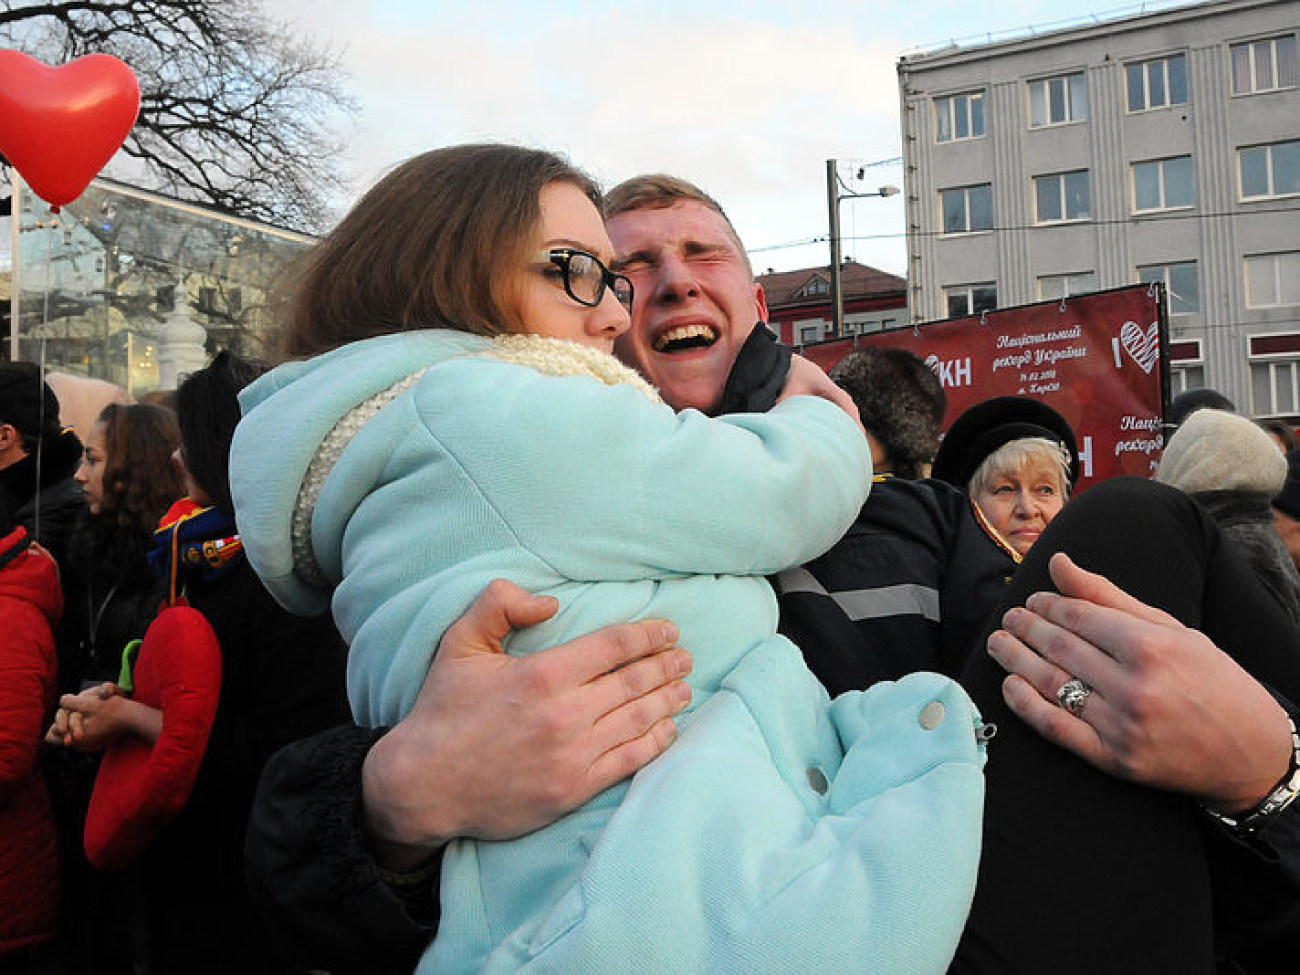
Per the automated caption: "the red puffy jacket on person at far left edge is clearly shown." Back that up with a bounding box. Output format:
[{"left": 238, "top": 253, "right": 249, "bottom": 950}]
[{"left": 0, "top": 528, "right": 64, "bottom": 954}]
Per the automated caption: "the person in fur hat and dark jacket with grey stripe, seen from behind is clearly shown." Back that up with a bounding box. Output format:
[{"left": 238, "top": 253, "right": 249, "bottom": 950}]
[{"left": 759, "top": 348, "right": 1019, "bottom": 697}]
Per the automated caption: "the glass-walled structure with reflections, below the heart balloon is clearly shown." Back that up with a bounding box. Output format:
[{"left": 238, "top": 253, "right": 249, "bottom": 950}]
[{"left": 0, "top": 178, "right": 313, "bottom": 397}]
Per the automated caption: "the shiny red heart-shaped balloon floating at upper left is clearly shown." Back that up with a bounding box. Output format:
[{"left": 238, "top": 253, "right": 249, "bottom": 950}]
[{"left": 0, "top": 51, "right": 140, "bottom": 207}]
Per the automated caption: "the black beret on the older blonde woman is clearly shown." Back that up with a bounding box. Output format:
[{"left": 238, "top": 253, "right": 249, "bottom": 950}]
[{"left": 931, "top": 397, "right": 1079, "bottom": 491}]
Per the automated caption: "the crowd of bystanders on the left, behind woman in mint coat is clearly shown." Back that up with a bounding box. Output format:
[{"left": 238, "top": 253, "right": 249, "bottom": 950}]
[{"left": 0, "top": 354, "right": 347, "bottom": 972}]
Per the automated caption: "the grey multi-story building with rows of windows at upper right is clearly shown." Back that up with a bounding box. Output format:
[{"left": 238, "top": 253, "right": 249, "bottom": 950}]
[{"left": 898, "top": 0, "right": 1300, "bottom": 419}]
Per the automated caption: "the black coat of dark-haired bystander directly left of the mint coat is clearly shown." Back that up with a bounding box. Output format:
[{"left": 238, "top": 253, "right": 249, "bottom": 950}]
[{"left": 144, "top": 559, "right": 348, "bottom": 974}]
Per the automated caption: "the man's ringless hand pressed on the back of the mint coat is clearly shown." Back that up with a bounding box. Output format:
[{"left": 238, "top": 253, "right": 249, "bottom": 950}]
[{"left": 361, "top": 580, "right": 690, "bottom": 870}]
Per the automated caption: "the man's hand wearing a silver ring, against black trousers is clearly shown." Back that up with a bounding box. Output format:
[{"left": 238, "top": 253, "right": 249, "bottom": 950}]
[{"left": 988, "top": 553, "right": 1292, "bottom": 814}]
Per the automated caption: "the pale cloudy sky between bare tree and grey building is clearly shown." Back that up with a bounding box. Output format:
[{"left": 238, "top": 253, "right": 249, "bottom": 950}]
[{"left": 267, "top": 0, "right": 1179, "bottom": 273}]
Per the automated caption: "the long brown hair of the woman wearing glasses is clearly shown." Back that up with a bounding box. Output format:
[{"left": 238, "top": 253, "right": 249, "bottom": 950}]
[{"left": 281, "top": 144, "right": 601, "bottom": 358}]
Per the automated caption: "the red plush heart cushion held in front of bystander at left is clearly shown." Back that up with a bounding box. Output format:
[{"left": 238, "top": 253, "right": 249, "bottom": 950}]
[{"left": 86, "top": 606, "right": 221, "bottom": 870}]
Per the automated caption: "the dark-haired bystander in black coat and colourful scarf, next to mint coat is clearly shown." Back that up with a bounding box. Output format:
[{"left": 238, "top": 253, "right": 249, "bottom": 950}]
[{"left": 52, "top": 361, "right": 348, "bottom": 974}]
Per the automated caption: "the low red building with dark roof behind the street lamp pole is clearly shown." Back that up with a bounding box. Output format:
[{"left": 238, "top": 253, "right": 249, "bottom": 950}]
[{"left": 758, "top": 260, "right": 907, "bottom": 346}]
